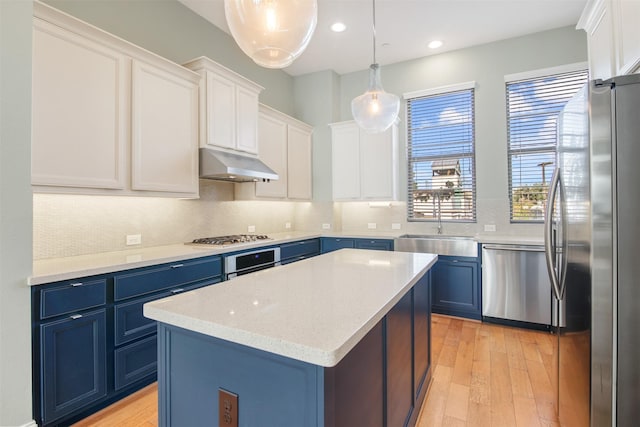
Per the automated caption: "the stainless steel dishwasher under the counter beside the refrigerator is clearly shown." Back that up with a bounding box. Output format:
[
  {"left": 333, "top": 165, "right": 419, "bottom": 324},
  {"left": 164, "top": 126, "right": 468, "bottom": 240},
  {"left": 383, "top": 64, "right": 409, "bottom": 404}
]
[{"left": 482, "top": 244, "right": 551, "bottom": 327}]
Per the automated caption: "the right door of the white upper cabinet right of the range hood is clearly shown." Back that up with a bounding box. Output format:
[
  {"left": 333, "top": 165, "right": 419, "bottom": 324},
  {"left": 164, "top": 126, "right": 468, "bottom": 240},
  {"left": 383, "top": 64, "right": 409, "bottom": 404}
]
[{"left": 287, "top": 125, "right": 312, "bottom": 200}]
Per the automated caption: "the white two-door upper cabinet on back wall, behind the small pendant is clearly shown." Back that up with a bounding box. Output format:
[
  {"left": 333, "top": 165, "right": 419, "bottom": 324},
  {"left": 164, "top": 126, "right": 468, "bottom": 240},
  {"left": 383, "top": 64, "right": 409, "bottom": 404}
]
[{"left": 331, "top": 121, "right": 398, "bottom": 201}]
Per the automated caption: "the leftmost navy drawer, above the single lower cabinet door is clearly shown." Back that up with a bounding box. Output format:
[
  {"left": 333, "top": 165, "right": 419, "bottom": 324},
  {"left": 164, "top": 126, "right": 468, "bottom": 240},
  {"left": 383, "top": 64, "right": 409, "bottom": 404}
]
[{"left": 40, "top": 279, "right": 107, "bottom": 319}]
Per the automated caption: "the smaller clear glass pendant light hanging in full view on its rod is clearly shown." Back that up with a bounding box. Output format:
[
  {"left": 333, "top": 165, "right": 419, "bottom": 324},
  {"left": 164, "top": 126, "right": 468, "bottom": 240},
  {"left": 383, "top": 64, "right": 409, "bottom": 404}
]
[{"left": 351, "top": 0, "right": 400, "bottom": 133}]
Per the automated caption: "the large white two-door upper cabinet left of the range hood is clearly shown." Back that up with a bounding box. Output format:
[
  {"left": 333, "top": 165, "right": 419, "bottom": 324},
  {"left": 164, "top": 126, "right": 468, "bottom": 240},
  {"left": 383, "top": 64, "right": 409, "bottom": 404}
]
[{"left": 31, "top": 2, "right": 200, "bottom": 197}]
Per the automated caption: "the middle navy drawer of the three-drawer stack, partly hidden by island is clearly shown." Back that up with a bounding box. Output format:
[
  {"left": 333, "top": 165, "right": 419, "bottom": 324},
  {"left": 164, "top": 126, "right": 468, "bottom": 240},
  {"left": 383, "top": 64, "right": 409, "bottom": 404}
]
[{"left": 114, "top": 278, "right": 220, "bottom": 346}]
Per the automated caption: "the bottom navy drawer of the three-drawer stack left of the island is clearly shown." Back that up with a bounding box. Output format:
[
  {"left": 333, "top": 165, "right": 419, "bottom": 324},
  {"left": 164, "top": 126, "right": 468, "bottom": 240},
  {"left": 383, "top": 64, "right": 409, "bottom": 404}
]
[{"left": 114, "top": 335, "right": 158, "bottom": 390}]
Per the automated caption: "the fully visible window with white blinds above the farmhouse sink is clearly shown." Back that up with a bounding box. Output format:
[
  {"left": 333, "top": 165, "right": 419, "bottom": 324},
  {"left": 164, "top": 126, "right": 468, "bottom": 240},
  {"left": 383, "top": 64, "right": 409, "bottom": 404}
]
[{"left": 405, "top": 82, "right": 476, "bottom": 222}]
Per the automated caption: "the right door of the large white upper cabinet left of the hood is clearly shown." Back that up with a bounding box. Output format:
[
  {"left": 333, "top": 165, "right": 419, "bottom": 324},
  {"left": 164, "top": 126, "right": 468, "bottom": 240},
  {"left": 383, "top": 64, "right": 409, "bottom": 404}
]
[{"left": 131, "top": 61, "right": 198, "bottom": 194}]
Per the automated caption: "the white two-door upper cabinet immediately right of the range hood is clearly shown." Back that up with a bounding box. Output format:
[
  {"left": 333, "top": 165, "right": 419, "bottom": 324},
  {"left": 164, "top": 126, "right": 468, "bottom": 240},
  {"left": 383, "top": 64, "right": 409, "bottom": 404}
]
[{"left": 248, "top": 105, "right": 313, "bottom": 200}]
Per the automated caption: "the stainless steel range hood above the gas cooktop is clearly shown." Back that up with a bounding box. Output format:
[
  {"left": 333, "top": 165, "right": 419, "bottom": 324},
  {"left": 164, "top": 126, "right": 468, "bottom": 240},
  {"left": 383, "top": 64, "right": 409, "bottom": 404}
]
[{"left": 200, "top": 148, "right": 278, "bottom": 182}]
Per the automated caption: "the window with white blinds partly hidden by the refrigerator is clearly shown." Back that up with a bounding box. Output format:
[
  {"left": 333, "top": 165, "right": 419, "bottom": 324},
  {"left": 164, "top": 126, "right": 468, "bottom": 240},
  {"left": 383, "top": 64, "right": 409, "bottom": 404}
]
[{"left": 506, "top": 70, "right": 588, "bottom": 222}]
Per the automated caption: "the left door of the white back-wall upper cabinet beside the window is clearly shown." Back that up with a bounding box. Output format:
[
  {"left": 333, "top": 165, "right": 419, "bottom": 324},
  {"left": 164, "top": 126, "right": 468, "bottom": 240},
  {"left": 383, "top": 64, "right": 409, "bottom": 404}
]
[{"left": 331, "top": 123, "right": 360, "bottom": 200}]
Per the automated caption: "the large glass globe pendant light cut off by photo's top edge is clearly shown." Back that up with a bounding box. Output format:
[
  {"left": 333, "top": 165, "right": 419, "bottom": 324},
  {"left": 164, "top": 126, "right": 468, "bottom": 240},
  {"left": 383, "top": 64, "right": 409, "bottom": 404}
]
[{"left": 224, "top": 0, "right": 318, "bottom": 68}]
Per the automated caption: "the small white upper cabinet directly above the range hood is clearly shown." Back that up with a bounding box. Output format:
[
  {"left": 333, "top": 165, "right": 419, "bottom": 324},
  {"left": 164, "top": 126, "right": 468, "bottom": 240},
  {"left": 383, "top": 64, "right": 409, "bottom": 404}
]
[{"left": 184, "top": 57, "right": 263, "bottom": 156}]
